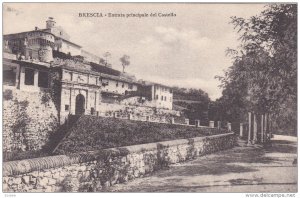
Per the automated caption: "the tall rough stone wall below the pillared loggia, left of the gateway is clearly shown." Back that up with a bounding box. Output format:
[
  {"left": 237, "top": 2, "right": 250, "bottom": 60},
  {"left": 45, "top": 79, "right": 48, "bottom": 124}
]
[{"left": 3, "top": 86, "right": 59, "bottom": 152}]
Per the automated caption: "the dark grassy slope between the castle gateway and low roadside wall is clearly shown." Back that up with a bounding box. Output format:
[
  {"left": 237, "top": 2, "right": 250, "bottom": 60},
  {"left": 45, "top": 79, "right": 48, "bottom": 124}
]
[{"left": 56, "top": 116, "right": 225, "bottom": 154}]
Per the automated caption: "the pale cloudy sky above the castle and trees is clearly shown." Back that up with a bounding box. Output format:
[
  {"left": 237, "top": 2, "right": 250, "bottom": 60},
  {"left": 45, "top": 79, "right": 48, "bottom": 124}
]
[{"left": 3, "top": 3, "right": 264, "bottom": 100}]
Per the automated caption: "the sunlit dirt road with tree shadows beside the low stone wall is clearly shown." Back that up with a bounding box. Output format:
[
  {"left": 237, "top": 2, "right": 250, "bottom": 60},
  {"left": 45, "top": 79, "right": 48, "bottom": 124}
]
[{"left": 107, "top": 135, "right": 297, "bottom": 192}]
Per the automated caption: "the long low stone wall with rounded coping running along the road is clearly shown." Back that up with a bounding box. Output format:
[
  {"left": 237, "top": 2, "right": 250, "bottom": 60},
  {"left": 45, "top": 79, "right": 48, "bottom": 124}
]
[{"left": 3, "top": 133, "right": 236, "bottom": 192}]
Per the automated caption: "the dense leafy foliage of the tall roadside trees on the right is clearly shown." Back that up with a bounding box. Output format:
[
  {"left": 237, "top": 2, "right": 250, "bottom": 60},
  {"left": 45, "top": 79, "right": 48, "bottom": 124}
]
[{"left": 218, "top": 4, "right": 297, "bottom": 135}]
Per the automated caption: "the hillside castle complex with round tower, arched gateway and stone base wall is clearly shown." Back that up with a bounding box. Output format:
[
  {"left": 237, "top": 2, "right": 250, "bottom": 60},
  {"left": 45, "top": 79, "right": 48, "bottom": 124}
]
[{"left": 3, "top": 17, "right": 180, "bottom": 152}]
